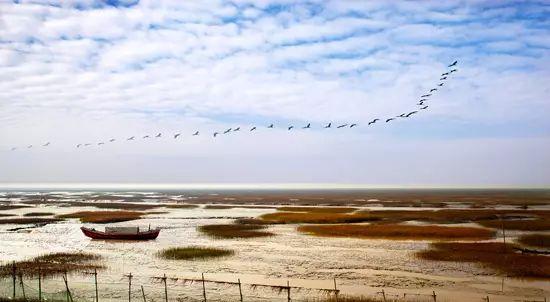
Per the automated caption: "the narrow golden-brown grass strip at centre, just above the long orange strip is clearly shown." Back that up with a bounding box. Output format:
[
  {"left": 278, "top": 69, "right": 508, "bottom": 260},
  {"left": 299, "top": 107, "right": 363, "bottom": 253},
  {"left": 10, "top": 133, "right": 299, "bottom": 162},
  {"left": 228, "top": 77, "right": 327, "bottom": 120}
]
[{"left": 259, "top": 212, "right": 380, "bottom": 224}]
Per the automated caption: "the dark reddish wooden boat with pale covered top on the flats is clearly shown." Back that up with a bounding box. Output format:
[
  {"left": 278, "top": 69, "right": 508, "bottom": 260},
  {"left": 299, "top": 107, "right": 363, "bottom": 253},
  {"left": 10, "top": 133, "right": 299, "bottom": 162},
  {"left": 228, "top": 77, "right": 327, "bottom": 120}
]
[{"left": 80, "top": 227, "right": 160, "bottom": 240}]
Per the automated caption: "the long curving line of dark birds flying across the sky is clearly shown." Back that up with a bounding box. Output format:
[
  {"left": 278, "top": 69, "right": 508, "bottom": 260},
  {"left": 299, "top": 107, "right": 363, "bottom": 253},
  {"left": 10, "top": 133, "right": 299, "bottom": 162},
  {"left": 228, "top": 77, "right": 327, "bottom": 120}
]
[{"left": 11, "top": 61, "right": 458, "bottom": 151}]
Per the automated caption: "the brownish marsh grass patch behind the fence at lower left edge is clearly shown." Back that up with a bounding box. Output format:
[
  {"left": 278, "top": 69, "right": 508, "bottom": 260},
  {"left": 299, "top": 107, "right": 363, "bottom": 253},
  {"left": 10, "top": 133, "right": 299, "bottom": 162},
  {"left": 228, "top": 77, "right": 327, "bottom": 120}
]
[{"left": 0, "top": 252, "right": 103, "bottom": 277}]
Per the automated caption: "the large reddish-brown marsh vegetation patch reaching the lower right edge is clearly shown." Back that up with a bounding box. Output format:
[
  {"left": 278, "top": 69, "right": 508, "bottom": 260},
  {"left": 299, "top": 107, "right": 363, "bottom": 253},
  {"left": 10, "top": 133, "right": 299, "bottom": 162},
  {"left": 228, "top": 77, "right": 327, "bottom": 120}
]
[{"left": 417, "top": 242, "right": 550, "bottom": 279}]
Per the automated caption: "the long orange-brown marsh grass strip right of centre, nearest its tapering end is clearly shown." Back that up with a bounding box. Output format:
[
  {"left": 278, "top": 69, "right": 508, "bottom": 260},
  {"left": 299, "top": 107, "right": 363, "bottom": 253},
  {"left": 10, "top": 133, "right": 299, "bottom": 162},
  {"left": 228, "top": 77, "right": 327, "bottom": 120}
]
[{"left": 298, "top": 224, "right": 495, "bottom": 240}]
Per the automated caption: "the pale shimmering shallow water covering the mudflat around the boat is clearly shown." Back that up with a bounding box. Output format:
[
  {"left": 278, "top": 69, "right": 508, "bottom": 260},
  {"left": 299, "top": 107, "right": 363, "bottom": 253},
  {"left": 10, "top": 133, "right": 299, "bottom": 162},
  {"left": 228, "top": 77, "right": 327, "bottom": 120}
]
[{"left": 0, "top": 192, "right": 550, "bottom": 302}]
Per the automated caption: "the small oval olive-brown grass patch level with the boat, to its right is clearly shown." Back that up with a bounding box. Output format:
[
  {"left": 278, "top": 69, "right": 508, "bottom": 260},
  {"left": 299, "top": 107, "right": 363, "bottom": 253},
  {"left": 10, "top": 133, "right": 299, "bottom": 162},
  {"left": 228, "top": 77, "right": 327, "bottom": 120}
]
[{"left": 198, "top": 224, "right": 275, "bottom": 239}]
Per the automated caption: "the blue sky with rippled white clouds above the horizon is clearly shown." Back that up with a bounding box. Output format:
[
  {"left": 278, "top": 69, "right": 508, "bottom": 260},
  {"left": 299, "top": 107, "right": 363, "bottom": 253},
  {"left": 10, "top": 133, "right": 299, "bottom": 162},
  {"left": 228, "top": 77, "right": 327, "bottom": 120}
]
[{"left": 0, "top": 0, "right": 550, "bottom": 187}]
